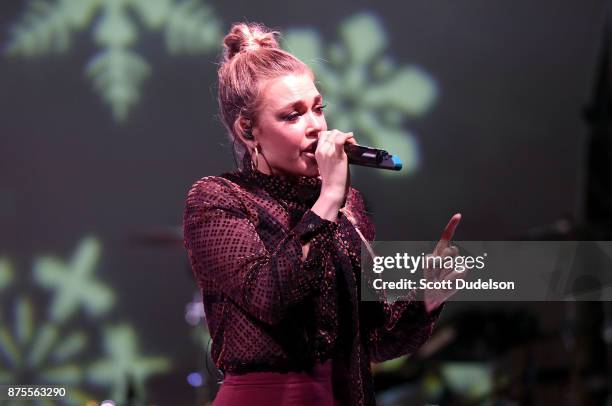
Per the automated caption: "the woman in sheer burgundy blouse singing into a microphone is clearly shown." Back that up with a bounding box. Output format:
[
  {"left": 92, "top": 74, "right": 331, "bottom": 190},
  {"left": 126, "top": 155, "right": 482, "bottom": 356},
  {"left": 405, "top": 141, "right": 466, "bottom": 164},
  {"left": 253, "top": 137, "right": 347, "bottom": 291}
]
[{"left": 184, "top": 24, "right": 456, "bottom": 406}]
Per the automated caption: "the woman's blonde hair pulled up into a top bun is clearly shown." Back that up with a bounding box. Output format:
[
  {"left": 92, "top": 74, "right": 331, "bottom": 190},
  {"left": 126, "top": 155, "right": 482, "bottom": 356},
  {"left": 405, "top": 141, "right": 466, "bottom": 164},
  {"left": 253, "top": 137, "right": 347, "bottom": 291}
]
[{"left": 218, "top": 23, "right": 314, "bottom": 162}]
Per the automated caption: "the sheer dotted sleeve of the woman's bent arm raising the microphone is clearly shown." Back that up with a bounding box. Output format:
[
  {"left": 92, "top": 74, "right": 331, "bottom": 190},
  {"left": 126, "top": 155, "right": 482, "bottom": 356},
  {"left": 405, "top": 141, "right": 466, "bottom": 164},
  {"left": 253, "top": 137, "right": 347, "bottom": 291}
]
[{"left": 183, "top": 177, "right": 337, "bottom": 324}]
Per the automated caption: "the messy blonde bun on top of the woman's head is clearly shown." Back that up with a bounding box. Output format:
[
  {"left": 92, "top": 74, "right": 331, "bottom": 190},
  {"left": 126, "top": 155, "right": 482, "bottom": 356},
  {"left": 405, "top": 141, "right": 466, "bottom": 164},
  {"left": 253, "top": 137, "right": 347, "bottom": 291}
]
[{"left": 223, "top": 23, "right": 279, "bottom": 61}]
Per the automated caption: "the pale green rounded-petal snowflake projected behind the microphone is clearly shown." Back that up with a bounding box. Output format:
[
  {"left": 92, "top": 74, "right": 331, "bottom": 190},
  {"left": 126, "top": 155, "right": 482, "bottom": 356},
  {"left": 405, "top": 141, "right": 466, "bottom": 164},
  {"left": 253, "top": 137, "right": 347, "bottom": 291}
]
[{"left": 284, "top": 13, "right": 437, "bottom": 174}]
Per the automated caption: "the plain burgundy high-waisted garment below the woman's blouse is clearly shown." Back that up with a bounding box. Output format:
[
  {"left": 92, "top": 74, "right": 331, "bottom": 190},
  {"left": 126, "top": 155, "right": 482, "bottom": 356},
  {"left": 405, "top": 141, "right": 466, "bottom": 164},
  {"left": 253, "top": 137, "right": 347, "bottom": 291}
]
[{"left": 213, "top": 360, "right": 340, "bottom": 406}]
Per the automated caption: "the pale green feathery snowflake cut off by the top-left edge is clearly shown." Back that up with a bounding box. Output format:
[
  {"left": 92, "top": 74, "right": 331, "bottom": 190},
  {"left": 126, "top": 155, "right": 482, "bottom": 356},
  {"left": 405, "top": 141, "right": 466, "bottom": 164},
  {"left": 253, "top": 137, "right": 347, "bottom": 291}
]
[{"left": 5, "top": 0, "right": 221, "bottom": 122}]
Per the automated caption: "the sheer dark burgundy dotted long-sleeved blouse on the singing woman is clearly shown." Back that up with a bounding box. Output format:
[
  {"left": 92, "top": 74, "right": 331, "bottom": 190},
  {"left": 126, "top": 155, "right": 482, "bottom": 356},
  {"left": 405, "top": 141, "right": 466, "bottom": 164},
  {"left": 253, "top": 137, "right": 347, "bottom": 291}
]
[{"left": 183, "top": 165, "right": 441, "bottom": 405}]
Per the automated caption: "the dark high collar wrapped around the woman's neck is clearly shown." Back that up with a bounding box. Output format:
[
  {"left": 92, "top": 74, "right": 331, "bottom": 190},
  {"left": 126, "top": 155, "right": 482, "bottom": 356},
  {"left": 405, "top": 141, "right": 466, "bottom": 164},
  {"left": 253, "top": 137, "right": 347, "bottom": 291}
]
[{"left": 238, "top": 154, "right": 321, "bottom": 205}]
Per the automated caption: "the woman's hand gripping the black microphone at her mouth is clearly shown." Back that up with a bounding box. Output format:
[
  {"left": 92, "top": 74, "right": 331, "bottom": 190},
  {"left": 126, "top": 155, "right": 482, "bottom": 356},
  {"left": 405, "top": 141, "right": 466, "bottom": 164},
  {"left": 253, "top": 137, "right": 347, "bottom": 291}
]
[{"left": 315, "top": 130, "right": 357, "bottom": 210}]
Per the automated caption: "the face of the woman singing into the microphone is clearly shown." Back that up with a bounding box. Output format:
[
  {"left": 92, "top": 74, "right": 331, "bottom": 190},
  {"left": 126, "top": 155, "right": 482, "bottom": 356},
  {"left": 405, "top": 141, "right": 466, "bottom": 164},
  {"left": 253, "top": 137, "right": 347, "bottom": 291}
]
[{"left": 252, "top": 73, "right": 327, "bottom": 176}]
